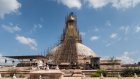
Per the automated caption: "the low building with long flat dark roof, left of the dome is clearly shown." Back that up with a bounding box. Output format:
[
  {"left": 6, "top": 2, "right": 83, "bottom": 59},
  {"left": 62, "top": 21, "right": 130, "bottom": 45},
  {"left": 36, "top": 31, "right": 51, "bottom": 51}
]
[{"left": 4, "top": 55, "right": 47, "bottom": 67}]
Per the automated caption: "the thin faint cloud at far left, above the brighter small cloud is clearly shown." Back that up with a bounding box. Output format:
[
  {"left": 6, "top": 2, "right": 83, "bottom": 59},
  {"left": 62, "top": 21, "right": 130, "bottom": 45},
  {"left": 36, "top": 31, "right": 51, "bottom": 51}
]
[{"left": 1, "top": 23, "right": 21, "bottom": 33}]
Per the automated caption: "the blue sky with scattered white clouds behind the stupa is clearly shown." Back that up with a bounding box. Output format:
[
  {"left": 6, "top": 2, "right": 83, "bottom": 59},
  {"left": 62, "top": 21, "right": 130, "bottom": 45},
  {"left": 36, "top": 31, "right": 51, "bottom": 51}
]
[{"left": 0, "top": 0, "right": 140, "bottom": 63}]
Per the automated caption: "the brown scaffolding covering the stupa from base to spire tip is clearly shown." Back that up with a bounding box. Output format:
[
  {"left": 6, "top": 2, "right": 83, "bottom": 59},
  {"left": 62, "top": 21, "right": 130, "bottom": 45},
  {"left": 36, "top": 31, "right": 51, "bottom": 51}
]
[{"left": 48, "top": 13, "right": 82, "bottom": 65}]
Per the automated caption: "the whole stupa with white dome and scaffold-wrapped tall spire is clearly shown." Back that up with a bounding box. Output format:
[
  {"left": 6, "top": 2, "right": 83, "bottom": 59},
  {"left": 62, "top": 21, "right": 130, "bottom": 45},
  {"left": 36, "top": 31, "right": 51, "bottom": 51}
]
[{"left": 47, "top": 13, "right": 96, "bottom": 68}]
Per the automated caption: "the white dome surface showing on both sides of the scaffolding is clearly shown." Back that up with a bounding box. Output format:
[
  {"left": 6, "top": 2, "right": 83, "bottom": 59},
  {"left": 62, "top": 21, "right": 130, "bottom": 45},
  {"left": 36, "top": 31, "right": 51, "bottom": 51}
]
[{"left": 50, "top": 43, "right": 96, "bottom": 57}]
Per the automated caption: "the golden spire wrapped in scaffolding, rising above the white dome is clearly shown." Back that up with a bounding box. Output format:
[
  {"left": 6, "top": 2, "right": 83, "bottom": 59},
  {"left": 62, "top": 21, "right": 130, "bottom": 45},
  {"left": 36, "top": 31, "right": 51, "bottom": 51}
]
[{"left": 61, "top": 12, "right": 81, "bottom": 43}]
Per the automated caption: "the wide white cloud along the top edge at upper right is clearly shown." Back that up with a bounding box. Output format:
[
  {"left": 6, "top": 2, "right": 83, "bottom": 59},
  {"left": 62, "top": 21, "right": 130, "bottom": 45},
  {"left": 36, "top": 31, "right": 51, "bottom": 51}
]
[{"left": 87, "top": 0, "right": 140, "bottom": 9}]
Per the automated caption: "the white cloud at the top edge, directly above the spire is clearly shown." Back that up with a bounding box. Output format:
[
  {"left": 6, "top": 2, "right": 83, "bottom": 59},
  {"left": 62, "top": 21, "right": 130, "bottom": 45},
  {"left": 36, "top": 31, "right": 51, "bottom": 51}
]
[{"left": 57, "top": 0, "right": 82, "bottom": 9}]
